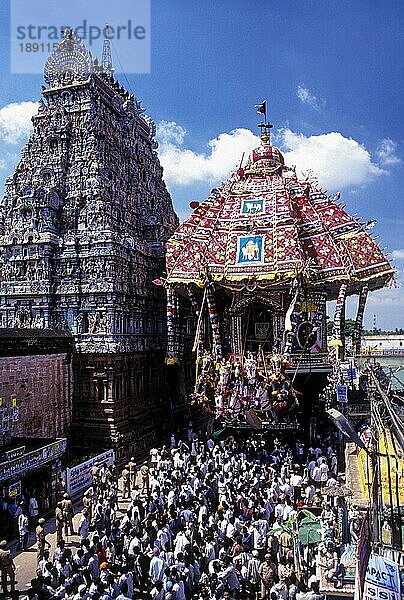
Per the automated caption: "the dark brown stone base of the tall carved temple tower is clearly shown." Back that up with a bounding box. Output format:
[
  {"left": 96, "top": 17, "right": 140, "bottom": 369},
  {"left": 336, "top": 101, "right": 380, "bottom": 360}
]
[{"left": 71, "top": 352, "right": 171, "bottom": 464}]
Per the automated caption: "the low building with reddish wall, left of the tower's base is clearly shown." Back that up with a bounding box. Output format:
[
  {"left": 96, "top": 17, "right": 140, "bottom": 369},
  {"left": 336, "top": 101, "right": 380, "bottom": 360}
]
[{"left": 0, "top": 328, "right": 73, "bottom": 537}]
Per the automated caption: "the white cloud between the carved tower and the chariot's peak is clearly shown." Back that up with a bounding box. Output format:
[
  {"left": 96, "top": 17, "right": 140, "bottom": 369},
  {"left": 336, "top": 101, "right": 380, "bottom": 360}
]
[{"left": 157, "top": 121, "right": 260, "bottom": 186}]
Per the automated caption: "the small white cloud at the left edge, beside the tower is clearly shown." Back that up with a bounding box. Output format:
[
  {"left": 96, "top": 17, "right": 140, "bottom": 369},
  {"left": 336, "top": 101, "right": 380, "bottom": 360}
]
[{"left": 0, "top": 102, "right": 38, "bottom": 144}]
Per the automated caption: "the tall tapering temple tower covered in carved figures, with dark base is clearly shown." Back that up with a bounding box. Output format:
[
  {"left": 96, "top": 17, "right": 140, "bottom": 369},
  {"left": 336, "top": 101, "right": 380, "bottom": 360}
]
[{"left": 0, "top": 29, "right": 178, "bottom": 462}]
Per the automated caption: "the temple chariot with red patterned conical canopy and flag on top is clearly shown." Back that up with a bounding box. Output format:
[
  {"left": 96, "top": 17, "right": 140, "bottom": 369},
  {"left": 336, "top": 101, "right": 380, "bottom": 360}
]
[{"left": 164, "top": 103, "right": 394, "bottom": 428}]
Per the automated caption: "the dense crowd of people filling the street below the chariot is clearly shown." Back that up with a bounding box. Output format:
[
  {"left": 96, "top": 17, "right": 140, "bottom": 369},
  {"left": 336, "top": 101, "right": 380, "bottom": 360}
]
[{"left": 3, "top": 428, "right": 350, "bottom": 600}]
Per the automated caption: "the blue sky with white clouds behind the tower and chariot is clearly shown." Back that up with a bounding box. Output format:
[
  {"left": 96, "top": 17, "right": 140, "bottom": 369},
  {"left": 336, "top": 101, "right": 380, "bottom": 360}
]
[{"left": 0, "top": 0, "right": 404, "bottom": 328}]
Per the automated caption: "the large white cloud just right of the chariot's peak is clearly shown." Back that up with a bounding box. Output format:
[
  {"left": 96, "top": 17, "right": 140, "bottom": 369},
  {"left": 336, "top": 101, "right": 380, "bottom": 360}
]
[{"left": 278, "top": 129, "right": 386, "bottom": 190}]
